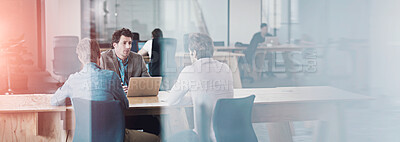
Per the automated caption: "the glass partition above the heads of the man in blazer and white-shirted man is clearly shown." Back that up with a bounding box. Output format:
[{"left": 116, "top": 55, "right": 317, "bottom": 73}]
[{"left": 82, "top": 0, "right": 228, "bottom": 51}]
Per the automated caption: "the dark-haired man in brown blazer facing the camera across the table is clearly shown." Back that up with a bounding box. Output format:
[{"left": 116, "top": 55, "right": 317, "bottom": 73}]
[{"left": 100, "top": 28, "right": 160, "bottom": 135}]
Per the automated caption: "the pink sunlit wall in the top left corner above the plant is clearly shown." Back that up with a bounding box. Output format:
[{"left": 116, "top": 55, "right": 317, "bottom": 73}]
[{"left": 0, "top": 0, "right": 38, "bottom": 66}]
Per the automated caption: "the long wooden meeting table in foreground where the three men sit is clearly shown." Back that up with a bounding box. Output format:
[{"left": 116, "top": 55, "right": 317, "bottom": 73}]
[{"left": 0, "top": 86, "right": 371, "bottom": 142}]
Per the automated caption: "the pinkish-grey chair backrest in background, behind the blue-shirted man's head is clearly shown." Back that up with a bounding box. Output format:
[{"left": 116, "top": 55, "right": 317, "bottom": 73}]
[{"left": 53, "top": 36, "right": 81, "bottom": 77}]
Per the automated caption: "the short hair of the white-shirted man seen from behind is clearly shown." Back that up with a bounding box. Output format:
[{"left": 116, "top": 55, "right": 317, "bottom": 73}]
[{"left": 188, "top": 33, "right": 214, "bottom": 59}]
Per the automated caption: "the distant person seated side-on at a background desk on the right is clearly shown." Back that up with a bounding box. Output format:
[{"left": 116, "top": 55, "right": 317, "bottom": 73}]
[{"left": 244, "top": 23, "right": 275, "bottom": 77}]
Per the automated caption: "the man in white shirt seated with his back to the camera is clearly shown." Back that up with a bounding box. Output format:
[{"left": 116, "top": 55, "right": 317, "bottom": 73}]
[{"left": 165, "top": 33, "right": 233, "bottom": 141}]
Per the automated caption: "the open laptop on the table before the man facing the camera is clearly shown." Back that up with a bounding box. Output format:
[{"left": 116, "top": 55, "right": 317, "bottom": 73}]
[{"left": 128, "top": 77, "right": 162, "bottom": 97}]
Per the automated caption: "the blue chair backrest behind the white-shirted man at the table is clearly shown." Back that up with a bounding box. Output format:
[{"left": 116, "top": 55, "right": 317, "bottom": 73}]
[{"left": 213, "top": 95, "right": 258, "bottom": 142}]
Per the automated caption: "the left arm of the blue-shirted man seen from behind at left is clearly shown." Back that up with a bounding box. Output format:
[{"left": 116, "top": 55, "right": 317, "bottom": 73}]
[{"left": 50, "top": 80, "right": 72, "bottom": 106}]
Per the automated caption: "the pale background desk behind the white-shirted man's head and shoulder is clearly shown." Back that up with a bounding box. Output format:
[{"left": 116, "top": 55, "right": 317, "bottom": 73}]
[{"left": 175, "top": 52, "right": 244, "bottom": 88}]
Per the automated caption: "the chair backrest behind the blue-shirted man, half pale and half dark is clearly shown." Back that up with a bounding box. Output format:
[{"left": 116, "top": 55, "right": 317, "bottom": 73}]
[{"left": 72, "top": 98, "right": 125, "bottom": 142}]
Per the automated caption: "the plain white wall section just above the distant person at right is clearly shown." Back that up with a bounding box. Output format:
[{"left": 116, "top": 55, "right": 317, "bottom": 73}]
[{"left": 229, "top": 0, "right": 261, "bottom": 43}]
